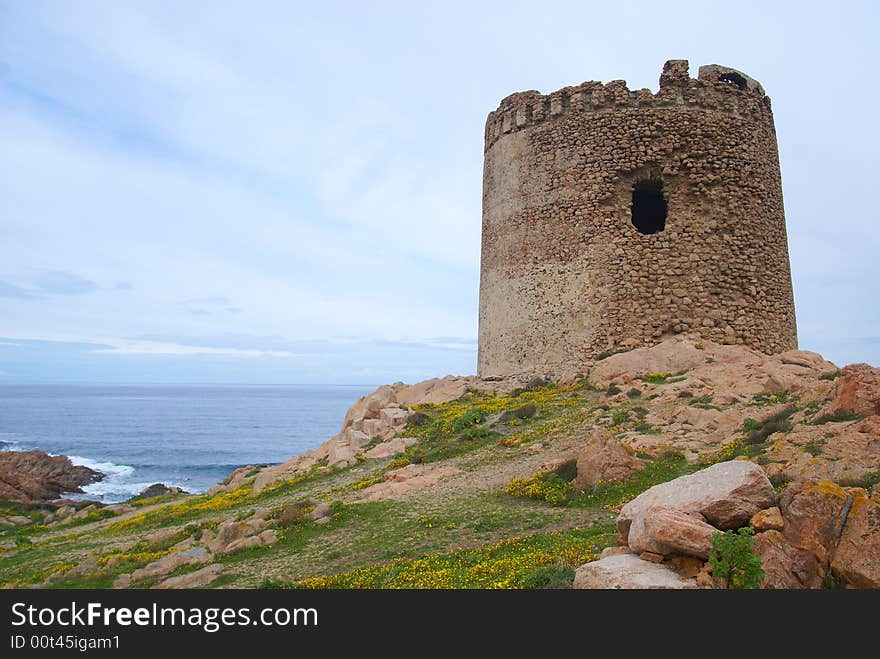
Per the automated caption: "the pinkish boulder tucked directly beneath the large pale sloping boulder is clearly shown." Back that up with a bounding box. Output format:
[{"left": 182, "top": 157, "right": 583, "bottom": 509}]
[{"left": 628, "top": 506, "right": 718, "bottom": 560}]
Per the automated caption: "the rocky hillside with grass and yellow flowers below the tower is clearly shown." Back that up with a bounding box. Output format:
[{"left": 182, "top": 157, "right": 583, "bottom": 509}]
[{"left": 0, "top": 337, "right": 880, "bottom": 588}]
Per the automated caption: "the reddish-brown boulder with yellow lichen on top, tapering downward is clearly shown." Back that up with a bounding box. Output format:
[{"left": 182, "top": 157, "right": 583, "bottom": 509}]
[{"left": 779, "top": 480, "right": 853, "bottom": 576}]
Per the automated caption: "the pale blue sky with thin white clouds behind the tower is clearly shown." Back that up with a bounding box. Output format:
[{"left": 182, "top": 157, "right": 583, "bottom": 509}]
[{"left": 0, "top": 0, "right": 880, "bottom": 384}]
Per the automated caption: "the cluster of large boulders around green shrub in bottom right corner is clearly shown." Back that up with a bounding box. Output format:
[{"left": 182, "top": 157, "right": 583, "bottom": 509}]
[{"left": 574, "top": 460, "right": 880, "bottom": 589}]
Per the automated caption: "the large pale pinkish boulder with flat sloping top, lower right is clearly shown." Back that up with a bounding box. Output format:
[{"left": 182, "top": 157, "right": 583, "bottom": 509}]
[{"left": 617, "top": 460, "right": 776, "bottom": 536}]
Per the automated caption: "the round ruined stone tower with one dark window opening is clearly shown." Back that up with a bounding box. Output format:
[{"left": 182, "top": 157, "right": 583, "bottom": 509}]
[{"left": 478, "top": 60, "right": 797, "bottom": 377}]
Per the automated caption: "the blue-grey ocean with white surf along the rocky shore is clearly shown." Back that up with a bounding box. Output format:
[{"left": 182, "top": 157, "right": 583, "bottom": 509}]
[{"left": 0, "top": 384, "right": 375, "bottom": 503}]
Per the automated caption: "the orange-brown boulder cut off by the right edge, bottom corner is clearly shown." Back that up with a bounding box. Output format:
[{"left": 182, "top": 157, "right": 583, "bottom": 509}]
[{"left": 831, "top": 488, "right": 880, "bottom": 588}]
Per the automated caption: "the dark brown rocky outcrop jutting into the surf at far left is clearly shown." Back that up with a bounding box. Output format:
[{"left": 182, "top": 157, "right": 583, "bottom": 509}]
[{"left": 0, "top": 451, "right": 104, "bottom": 503}]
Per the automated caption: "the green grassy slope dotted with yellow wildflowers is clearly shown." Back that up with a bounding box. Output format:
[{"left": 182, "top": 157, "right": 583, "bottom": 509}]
[{"left": 0, "top": 383, "right": 820, "bottom": 588}]
